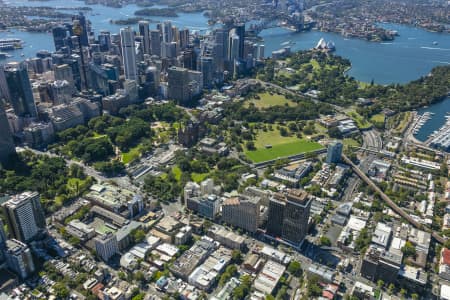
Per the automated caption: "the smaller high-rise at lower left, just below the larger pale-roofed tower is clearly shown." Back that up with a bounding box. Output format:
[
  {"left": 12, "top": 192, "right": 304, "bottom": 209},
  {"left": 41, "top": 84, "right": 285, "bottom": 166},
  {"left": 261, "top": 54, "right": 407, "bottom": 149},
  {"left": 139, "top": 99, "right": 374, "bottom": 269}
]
[{"left": 5, "top": 239, "right": 35, "bottom": 279}]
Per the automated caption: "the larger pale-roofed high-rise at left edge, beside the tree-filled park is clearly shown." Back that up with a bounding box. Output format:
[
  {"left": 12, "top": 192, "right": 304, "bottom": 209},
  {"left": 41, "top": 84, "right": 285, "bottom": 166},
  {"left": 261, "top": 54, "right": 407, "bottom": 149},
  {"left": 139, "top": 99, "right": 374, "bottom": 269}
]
[{"left": 2, "top": 192, "right": 45, "bottom": 243}]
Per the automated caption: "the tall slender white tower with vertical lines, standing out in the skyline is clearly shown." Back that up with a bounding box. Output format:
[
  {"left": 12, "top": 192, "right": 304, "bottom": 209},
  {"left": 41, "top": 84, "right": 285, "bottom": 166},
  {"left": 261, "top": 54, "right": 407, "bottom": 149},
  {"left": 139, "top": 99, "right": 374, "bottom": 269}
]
[{"left": 120, "top": 27, "right": 137, "bottom": 80}]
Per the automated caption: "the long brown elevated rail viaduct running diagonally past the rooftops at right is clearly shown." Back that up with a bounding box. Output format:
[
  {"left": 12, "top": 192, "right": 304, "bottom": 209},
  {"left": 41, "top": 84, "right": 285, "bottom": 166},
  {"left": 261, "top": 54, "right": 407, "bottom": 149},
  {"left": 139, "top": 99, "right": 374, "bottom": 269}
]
[{"left": 342, "top": 154, "right": 446, "bottom": 244}]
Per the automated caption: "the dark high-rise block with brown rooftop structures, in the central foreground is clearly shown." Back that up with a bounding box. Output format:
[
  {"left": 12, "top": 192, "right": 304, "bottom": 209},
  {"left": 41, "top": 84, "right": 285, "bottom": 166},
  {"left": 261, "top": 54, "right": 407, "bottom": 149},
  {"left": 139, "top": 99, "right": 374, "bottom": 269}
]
[{"left": 267, "top": 189, "right": 312, "bottom": 246}]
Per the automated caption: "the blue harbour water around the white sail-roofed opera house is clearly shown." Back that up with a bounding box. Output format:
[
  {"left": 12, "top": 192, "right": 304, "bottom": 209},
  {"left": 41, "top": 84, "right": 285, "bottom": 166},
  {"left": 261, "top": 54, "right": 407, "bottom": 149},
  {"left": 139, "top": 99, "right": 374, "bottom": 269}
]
[{"left": 261, "top": 24, "right": 450, "bottom": 84}]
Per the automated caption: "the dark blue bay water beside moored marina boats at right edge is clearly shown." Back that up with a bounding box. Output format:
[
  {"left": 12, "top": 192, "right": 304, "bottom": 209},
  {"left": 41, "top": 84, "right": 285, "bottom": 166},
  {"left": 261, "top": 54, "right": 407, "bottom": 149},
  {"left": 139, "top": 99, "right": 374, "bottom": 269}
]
[{"left": 414, "top": 97, "right": 450, "bottom": 142}]
